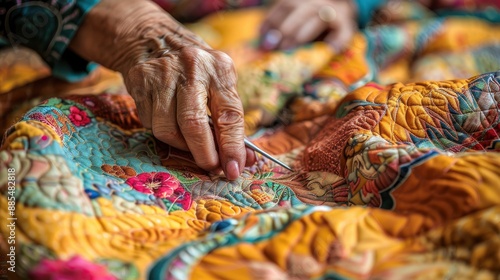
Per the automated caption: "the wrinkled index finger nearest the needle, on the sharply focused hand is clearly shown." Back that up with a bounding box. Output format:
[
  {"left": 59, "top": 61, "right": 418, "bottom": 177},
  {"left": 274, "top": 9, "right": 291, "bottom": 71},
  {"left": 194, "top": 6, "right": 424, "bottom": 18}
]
[{"left": 209, "top": 51, "right": 247, "bottom": 180}]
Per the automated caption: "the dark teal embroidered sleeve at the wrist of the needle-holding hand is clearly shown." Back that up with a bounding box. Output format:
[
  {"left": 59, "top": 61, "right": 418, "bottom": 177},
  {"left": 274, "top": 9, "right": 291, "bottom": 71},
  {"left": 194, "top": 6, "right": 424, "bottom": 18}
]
[{"left": 0, "top": 0, "right": 99, "bottom": 81}]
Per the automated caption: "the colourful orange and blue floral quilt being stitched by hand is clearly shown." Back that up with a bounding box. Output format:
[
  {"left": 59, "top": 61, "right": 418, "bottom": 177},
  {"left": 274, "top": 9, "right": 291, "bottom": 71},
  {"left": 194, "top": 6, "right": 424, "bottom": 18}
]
[{"left": 0, "top": 3, "right": 500, "bottom": 279}]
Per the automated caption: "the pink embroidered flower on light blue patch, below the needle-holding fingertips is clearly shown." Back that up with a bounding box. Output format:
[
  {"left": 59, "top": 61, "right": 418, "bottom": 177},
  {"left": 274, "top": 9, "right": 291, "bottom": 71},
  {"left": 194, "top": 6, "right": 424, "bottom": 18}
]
[{"left": 126, "top": 172, "right": 182, "bottom": 198}]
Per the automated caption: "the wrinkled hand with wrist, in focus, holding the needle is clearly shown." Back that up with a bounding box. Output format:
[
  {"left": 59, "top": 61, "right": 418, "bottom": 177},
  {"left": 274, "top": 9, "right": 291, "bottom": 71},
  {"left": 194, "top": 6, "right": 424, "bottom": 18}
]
[{"left": 70, "top": 0, "right": 254, "bottom": 180}]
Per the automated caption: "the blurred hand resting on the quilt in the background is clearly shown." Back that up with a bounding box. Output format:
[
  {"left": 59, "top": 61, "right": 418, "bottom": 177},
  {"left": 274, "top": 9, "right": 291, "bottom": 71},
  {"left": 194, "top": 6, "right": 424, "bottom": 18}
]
[{"left": 261, "top": 0, "right": 357, "bottom": 51}]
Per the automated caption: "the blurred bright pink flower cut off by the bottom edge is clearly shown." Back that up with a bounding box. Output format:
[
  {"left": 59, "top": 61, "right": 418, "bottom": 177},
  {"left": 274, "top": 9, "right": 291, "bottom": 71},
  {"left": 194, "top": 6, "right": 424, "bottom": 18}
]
[{"left": 30, "top": 256, "right": 116, "bottom": 280}]
